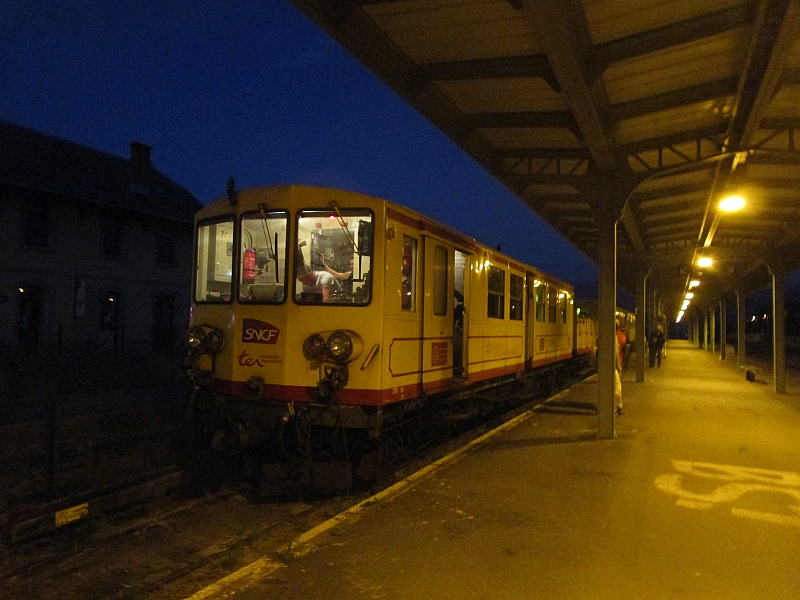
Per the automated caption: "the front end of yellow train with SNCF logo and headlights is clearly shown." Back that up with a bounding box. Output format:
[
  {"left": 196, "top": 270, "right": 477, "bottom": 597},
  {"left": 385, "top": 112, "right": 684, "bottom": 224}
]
[{"left": 180, "top": 186, "right": 383, "bottom": 490}]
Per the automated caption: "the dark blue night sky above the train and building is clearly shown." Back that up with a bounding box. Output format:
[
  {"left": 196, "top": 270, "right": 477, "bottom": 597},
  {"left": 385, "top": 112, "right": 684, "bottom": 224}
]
[{"left": 0, "top": 0, "right": 597, "bottom": 283}]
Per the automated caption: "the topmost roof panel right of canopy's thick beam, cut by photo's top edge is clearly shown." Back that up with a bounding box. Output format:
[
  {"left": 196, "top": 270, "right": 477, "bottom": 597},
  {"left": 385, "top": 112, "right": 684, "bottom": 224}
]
[{"left": 583, "top": 0, "right": 748, "bottom": 44}]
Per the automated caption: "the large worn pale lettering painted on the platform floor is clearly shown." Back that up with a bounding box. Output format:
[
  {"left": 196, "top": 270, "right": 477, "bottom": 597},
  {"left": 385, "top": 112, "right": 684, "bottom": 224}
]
[{"left": 655, "top": 460, "right": 800, "bottom": 527}]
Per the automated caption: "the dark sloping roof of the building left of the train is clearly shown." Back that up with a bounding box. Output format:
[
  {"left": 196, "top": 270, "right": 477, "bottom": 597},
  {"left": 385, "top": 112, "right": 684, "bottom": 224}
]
[{"left": 0, "top": 120, "right": 202, "bottom": 223}]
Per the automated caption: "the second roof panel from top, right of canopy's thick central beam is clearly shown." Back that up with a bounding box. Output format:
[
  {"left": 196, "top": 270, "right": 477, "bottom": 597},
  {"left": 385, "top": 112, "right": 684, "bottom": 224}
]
[{"left": 603, "top": 29, "right": 748, "bottom": 104}]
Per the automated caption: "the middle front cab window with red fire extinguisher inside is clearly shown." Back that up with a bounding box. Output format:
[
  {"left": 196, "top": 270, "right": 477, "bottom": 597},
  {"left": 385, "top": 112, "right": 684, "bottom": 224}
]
[{"left": 239, "top": 207, "right": 289, "bottom": 304}]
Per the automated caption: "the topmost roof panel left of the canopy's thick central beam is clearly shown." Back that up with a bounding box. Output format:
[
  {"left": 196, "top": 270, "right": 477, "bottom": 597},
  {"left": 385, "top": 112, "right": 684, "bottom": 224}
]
[{"left": 364, "top": 0, "right": 541, "bottom": 64}]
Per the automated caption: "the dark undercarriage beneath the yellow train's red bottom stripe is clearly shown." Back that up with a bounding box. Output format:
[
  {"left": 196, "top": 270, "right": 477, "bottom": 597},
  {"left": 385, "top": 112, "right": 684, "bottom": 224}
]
[{"left": 181, "top": 357, "right": 593, "bottom": 496}]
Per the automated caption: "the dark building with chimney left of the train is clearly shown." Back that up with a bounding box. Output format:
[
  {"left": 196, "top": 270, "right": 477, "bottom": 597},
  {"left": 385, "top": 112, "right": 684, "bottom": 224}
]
[{"left": 0, "top": 121, "right": 201, "bottom": 356}]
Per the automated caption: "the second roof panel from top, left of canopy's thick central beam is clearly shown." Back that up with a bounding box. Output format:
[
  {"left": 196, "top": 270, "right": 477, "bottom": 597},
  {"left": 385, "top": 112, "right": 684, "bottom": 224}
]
[{"left": 436, "top": 77, "right": 568, "bottom": 114}]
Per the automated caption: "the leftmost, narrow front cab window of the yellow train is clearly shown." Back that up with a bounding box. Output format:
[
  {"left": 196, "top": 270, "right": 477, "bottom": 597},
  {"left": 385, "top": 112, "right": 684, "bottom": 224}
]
[{"left": 194, "top": 217, "right": 234, "bottom": 302}]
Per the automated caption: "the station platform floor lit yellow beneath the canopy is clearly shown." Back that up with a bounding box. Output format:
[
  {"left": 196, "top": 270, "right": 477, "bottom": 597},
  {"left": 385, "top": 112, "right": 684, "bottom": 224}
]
[{"left": 195, "top": 341, "right": 800, "bottom": 600}]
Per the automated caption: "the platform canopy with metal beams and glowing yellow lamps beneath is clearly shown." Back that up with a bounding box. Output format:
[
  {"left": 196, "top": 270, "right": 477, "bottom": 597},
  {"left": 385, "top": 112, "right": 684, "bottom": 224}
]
[{"left": 292, "top": 0, "right": 800, "bottom": 318}]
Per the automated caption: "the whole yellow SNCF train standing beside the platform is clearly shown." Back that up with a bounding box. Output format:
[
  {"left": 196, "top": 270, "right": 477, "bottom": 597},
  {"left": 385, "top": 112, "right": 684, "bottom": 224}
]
[{"left": 181, "top": 185, "right": 595, "bottom": 490}]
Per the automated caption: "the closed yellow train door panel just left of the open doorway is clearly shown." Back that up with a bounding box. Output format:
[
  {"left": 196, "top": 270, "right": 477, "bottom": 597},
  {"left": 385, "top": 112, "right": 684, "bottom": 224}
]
[{"left": 422, "top": 237, "right": 455, "bottom": 389}]
